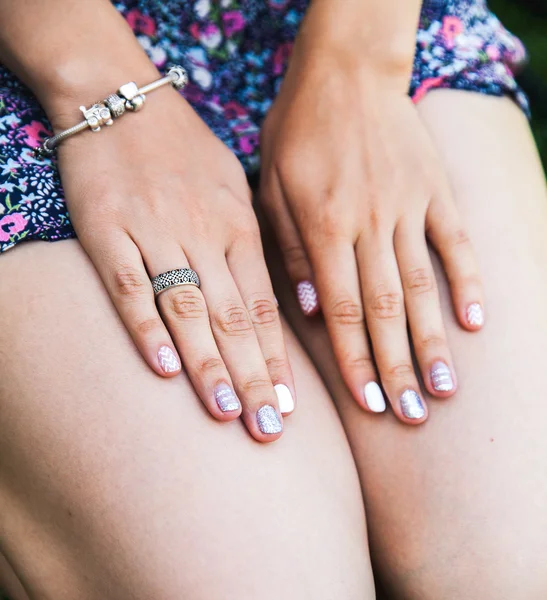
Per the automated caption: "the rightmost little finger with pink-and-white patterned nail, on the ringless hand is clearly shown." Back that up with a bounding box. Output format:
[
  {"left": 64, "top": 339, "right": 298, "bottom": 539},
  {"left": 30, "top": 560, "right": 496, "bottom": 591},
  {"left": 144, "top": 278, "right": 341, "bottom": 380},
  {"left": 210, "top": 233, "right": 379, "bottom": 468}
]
[{"left": 426, "top": 186, "right": 484, "bottom": 331}]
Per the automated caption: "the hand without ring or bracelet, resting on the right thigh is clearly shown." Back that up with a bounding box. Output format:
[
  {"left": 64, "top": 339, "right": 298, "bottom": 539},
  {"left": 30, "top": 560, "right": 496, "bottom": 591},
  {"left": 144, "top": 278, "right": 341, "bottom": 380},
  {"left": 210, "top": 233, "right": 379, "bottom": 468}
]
[{"left": 261, "top": 41, "right": 483, "bottom": 424}]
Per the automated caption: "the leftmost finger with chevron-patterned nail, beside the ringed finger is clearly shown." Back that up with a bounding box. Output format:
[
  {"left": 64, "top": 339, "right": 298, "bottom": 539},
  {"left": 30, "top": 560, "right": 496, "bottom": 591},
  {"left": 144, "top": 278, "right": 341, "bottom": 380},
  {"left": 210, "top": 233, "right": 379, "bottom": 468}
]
[{"left": 86, "top": 232, "right": 181, "bottom": 377}]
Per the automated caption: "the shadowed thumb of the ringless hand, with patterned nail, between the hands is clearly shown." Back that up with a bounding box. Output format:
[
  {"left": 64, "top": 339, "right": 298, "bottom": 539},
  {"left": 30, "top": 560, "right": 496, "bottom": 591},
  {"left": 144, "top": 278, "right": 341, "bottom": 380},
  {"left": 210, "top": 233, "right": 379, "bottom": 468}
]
[{"left": 261, "top": 174, "right": 320, "bottom": 317}]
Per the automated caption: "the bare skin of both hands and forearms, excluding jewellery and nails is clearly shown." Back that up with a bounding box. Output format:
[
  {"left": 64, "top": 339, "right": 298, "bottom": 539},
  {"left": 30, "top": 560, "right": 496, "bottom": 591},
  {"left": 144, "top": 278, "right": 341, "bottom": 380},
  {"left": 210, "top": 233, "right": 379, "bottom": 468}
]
[{"left": 0, "top": 0, "right": 482, "bottom": 442}]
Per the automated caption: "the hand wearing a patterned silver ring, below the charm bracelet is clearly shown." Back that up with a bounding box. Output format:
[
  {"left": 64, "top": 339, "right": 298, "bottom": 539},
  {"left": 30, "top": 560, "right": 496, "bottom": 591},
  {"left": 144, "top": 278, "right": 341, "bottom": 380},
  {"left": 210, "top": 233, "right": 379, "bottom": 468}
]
[{"left": 54, "top": 82, "right": 295, "bottom": 442}]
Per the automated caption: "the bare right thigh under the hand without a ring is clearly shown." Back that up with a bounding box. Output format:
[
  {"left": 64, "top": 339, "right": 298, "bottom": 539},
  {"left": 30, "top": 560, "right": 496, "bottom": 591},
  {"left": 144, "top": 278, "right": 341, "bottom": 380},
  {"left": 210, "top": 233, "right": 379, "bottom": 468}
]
[{"left": 270, "top": 90, "right": 547, "bottom": 600}]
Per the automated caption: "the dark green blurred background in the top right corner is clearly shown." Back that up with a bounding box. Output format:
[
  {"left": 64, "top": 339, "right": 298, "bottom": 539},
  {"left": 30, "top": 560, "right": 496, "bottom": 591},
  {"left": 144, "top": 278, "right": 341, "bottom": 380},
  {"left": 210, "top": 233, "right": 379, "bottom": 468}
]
[{"left": 488, "top": 0, "right": 547, "bottom": 170}]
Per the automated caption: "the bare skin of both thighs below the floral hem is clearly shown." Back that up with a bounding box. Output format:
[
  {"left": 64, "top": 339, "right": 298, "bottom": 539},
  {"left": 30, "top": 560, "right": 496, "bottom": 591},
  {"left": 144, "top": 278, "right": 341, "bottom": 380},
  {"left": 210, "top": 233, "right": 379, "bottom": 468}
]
[{"left": 0, "top": 91, "right": 547, "bottom": 600}]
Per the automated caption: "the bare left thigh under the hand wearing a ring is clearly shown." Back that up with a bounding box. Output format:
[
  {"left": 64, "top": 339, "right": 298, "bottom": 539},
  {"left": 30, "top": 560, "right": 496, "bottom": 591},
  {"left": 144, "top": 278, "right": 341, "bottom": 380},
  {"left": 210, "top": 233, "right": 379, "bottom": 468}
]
[{"left": 0, "top": 240, "right": 374, "bottom": 600}]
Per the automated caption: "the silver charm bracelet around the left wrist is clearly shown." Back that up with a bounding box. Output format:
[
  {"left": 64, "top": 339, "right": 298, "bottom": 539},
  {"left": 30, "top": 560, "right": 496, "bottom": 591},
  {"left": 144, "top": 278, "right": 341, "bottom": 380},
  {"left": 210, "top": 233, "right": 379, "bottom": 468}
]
[{"left": 34, "top": 65, "right": 188, "bottom": 158}]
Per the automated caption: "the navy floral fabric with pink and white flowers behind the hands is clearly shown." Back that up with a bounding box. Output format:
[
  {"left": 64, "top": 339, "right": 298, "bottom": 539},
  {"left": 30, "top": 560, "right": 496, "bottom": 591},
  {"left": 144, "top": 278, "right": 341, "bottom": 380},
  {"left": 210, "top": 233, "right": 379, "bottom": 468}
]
[{"left": 0, "top": 0, "right": 528, "bottom": 251}]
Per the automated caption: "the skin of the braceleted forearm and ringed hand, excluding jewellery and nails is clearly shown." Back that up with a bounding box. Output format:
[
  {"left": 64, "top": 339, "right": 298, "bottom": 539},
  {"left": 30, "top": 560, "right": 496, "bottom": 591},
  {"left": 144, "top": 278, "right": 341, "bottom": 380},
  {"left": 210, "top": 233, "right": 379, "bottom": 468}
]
[{"left": 0, "top": 0, "right": 296, "bottom": 442}]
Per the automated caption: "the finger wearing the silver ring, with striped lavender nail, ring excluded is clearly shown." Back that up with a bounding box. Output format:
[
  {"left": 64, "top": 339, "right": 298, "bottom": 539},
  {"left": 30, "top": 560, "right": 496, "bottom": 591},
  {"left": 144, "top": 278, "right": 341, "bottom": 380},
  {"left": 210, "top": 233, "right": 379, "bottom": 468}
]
[{"left": 142, "top": 241, "right": 241, "bottom": 421}]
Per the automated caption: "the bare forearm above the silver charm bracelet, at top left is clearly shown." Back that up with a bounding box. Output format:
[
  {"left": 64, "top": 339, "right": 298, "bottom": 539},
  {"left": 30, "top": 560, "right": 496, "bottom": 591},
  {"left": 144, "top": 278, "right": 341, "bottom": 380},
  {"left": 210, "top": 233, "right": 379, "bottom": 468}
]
[{"left": 0, "top": 0, "right": 158, "bottom": 126}]
